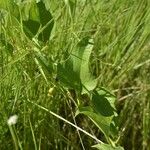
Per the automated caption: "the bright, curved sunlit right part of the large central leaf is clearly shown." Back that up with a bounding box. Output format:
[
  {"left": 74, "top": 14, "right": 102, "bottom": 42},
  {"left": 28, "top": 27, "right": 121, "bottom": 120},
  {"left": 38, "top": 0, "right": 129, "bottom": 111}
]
[{"left": 72, "top": 37, "right": 97, "bottom": 94}]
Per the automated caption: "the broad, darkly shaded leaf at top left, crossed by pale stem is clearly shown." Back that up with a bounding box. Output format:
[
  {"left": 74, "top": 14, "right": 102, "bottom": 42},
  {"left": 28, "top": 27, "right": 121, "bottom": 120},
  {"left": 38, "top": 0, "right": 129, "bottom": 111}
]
[{"left": 22, "top": 0, "right": 54, "bottom": 42}]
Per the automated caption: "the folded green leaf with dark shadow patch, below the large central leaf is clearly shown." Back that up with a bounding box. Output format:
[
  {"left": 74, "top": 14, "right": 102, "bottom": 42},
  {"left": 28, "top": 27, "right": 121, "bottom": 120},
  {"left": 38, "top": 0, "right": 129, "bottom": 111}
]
[{"left": 77, "top": 89, "right": 118, "bottom": 142}]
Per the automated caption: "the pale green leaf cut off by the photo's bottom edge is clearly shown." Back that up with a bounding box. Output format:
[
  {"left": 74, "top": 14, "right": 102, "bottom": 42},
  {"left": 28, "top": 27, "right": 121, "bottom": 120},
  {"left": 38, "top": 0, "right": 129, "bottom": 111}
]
[{"left": 92, "top": 143, "right": 124, "bottom": 150}]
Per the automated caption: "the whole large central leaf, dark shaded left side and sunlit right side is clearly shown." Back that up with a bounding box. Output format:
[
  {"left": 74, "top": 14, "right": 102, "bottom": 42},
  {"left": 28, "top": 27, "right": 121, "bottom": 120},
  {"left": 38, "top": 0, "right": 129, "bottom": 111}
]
[{"left": 58, "top": 38, "right": 97, "bottom": 94}]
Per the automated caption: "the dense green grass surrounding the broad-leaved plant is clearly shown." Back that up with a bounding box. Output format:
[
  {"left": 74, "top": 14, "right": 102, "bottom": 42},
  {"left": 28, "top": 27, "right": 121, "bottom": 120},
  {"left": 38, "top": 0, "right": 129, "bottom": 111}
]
[{"left": 0, "top": 0, "right": 150, "bottom": 150}]
